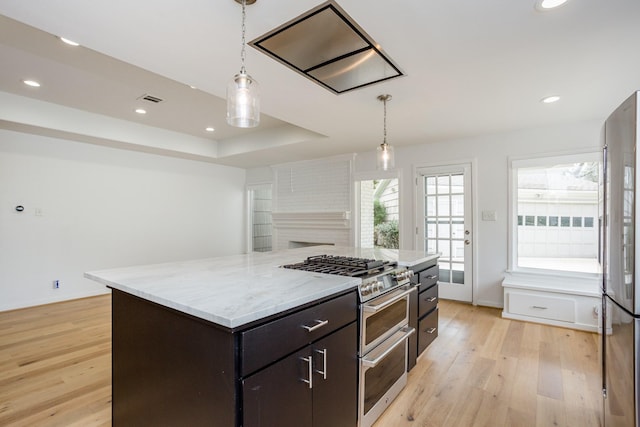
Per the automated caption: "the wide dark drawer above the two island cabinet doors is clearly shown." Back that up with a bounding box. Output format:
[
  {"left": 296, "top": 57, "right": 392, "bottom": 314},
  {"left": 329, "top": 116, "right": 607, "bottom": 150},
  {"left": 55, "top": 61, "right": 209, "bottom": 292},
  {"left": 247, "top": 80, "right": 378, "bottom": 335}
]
[{"left": 239, "top": 292, "right": 358, "bottom": 376}]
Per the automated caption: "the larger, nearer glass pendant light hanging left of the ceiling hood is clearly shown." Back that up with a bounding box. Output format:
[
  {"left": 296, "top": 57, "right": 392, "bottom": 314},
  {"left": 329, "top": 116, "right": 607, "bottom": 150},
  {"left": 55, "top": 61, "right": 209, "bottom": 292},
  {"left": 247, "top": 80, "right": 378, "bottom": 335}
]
[{"left": 227, "top": 0, "right": 260, "bottom": 128}]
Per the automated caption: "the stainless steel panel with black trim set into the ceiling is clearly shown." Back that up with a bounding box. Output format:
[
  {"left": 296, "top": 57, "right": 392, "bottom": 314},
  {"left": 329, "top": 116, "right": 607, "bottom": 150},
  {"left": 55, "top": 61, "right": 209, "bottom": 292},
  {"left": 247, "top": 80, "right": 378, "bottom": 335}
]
[{"left": 250, "top": 0, "right": 404, "bottom": 94}]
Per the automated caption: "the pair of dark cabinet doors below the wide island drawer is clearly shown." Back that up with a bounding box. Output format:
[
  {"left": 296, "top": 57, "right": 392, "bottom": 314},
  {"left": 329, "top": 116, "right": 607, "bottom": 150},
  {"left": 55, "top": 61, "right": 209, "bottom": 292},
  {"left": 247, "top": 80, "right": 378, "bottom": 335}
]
[{"left": 242, "top": 322, "right": 358, "bottom": 427}]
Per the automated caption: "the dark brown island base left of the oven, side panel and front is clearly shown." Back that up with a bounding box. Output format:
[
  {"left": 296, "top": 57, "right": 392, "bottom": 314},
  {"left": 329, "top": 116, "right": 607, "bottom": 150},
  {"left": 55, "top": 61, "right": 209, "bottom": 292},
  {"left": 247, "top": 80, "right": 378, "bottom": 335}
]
[{"left": 112, "top": 290, "right": 358, "bottom": 427}]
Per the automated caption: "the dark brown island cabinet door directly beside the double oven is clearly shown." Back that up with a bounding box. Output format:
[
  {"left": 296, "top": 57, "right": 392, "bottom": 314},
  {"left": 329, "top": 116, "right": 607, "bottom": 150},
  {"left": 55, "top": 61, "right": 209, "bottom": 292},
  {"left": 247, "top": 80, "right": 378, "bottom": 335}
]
[{"left": 312, "top": 322, "right": 358, "bottom": 427}]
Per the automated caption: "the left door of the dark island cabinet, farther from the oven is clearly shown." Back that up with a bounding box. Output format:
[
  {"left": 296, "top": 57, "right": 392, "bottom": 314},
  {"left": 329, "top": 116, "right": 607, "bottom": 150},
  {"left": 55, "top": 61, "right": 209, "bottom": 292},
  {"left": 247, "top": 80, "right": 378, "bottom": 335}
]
[{"left": 242, "top": 348, "right": 312, "bottom": 427}]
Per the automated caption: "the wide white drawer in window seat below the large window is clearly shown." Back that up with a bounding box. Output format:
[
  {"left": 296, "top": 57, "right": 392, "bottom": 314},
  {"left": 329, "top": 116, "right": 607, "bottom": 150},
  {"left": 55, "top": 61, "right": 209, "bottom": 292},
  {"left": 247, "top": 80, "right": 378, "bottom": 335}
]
[{"left": 509, "top": 292, "right": 576, "bottom": 322}]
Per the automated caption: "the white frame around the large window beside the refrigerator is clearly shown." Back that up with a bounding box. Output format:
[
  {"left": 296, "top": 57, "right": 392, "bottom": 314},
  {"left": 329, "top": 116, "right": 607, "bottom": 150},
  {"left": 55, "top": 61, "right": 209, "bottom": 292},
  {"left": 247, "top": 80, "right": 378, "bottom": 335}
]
[{"left": 507, "top": 150, "right": 602, "bottom": 278}]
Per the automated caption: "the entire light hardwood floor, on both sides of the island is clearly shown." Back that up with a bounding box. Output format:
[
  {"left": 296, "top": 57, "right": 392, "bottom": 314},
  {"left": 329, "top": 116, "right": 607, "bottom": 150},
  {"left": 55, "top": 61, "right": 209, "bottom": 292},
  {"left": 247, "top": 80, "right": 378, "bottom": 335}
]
[{"left": 0, "top": 296, "right": 600, "bottom": 427}]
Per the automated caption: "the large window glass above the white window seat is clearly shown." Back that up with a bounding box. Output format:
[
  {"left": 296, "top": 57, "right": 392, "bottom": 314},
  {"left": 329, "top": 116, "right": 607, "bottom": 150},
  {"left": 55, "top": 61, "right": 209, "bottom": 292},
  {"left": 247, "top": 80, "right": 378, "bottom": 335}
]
[{"left": 510, "top": 153, "right": 600, "bottom": 273}]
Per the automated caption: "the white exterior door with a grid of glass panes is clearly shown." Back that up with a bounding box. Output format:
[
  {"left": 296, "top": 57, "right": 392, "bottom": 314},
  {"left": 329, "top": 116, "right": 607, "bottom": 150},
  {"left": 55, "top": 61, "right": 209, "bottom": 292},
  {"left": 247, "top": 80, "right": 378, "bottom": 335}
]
[{"left": 416, "top": 163, "right": 473, "bottom": 302}]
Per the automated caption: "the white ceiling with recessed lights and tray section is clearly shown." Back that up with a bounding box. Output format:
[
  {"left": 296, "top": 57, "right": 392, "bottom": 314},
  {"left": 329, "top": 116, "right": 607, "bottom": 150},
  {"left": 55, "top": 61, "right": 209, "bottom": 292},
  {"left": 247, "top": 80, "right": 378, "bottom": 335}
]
[{"left": 0, "top": 0, "right": 640, "bottom": 167}]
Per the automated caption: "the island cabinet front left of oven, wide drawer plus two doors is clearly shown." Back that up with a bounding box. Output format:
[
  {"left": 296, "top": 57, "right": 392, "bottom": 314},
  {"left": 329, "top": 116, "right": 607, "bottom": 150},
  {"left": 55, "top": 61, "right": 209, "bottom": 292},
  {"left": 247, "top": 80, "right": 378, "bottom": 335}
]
[{"left": 242, "top": 295, "right": 358, "bottom": 427}]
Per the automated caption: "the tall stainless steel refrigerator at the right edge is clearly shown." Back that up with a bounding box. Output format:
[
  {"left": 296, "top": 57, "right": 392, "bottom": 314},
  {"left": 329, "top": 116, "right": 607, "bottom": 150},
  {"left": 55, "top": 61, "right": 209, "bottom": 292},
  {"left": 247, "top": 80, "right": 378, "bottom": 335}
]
[{"left": 601, "top": 92, "right": 640, "bottom": 427}]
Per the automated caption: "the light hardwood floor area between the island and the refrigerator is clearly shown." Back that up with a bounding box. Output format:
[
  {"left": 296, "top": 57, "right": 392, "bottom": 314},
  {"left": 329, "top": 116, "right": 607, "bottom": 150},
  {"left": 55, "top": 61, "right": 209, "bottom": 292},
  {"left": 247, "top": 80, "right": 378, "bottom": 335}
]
[{"left": 374, "top": 300, "right": 601, "bottom": 427}]
